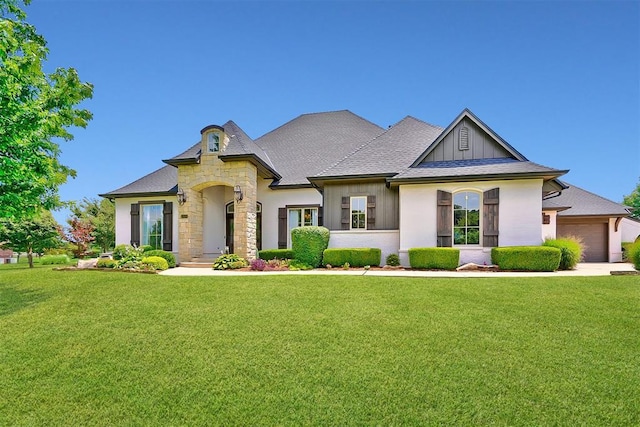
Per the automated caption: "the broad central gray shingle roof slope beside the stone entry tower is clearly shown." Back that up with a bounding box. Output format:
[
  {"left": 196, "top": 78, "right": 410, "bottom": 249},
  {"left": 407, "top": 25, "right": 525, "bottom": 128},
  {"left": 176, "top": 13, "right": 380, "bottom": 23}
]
[{"left": 256, "top": 110, "right": 383, "bottom": 186}]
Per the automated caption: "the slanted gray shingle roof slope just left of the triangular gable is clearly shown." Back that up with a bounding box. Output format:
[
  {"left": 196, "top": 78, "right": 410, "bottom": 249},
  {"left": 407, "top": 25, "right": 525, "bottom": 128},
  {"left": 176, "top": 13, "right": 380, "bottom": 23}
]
[{"left": 313, "top": 116, "right": 442, "bottom": 178}]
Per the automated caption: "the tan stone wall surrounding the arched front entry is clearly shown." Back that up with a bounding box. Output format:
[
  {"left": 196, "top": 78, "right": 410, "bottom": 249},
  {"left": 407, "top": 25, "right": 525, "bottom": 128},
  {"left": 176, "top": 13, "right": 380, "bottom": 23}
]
[{"left": 178, "top": 154, "right": 258, "bottom": 262}]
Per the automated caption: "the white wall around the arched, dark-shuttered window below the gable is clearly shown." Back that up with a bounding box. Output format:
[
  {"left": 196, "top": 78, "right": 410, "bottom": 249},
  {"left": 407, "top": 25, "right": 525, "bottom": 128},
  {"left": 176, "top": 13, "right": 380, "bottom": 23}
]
[{"left": 399, "top": 179, "right": 543, "bottom": 265}]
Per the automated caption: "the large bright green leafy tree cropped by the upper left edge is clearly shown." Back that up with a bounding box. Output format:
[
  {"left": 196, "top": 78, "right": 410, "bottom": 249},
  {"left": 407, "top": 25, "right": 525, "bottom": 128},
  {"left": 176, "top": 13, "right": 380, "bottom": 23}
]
[{"left": 0, "top": 0, "right": 93, "bottom": 219}]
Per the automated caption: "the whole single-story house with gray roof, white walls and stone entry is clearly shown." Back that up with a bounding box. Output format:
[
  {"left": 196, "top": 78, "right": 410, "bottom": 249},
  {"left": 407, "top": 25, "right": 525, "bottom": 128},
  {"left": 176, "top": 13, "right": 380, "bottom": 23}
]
[{"left": 101, "top": 109, "right": 628, "bottom": 265}]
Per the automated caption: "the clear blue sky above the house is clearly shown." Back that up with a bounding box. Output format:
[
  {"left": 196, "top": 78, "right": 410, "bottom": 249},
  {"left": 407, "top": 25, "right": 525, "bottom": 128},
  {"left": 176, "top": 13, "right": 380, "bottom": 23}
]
[{"left": 26, "top": 0, "right": 640, "bottom": 221}]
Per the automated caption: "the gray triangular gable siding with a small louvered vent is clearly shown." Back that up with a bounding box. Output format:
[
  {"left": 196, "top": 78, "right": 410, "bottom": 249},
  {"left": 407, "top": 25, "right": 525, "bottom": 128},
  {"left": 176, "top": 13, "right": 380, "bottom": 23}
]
[{"left": 422, "top": 119, "right": 512, "bottom": 163}]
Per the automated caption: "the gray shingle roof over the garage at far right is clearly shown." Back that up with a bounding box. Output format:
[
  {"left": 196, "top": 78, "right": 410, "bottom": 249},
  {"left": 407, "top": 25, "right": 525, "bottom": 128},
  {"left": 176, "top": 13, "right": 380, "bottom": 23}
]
[{"left": 542, "top": 184, "right": 629, "bottom": 216}]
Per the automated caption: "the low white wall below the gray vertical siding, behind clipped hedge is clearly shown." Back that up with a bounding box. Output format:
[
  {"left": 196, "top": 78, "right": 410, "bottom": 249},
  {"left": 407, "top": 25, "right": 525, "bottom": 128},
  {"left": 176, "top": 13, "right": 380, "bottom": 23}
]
[{"left": 329, "top": 230, "right": 400, "bottom": 265}]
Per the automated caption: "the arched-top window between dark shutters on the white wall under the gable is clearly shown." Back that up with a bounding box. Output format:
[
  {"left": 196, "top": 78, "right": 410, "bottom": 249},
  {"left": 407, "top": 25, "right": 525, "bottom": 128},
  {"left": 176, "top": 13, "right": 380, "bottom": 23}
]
[{"left": 453, "top": 191, "right": 480, "bottom": 245}]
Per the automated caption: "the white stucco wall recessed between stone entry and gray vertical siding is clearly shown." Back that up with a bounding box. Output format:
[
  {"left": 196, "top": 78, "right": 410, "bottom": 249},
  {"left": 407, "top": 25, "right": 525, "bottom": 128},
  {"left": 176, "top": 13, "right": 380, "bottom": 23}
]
[{"left": 258, "top": 178, "right": 322, "bottom": 249}]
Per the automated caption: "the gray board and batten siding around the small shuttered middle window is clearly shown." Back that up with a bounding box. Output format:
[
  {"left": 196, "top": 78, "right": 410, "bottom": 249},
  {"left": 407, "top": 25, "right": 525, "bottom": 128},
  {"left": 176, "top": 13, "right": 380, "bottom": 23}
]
[{"left": 324, "top": 182, "right": 399, "bottom": 230}]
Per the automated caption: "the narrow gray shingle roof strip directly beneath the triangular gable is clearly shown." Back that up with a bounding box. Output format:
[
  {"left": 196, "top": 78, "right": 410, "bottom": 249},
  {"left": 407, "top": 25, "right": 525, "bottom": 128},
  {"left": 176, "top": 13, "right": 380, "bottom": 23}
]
[{"left": 389, "top": 158, "right": 567, "bottom": 182}]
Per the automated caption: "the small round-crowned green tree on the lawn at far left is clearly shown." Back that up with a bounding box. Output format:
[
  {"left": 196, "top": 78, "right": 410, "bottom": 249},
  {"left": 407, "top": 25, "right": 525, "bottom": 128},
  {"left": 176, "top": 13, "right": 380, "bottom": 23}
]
[{"left": 0, "top": 211, "right": 61, "bottom": 268}]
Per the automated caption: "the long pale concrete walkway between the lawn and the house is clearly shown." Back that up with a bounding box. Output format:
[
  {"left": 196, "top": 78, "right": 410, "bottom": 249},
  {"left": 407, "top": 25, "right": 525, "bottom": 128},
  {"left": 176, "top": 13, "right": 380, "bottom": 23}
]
[{"left": 160, "top": 263, "right": 640, "bottom": 280}]
